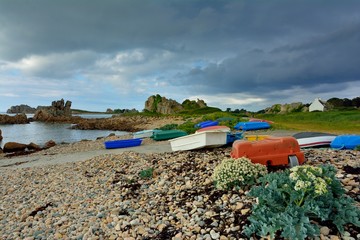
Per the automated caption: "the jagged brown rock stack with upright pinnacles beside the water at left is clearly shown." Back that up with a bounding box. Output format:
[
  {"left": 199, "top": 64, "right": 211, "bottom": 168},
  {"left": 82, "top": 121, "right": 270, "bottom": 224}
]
[{"left": 34, "top": 99, "right": 81, "bottom": 122}]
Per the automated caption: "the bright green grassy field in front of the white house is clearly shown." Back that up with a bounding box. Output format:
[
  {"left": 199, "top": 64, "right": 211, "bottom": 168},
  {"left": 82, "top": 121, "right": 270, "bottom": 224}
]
[{"left": 256, "top": 110, "right": 360, "bottom": 134}]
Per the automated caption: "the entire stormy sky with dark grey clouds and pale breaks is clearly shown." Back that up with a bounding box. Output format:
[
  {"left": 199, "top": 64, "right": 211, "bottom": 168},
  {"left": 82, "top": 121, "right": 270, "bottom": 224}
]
[{"left": 0, "top": 0, "right": 360, "bottom": 111}]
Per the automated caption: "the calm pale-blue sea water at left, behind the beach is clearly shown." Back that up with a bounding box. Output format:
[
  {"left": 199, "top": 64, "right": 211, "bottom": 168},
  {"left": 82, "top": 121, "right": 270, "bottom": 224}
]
[{"left": 0, "top": 113, "right": 128, "bottom": 147}]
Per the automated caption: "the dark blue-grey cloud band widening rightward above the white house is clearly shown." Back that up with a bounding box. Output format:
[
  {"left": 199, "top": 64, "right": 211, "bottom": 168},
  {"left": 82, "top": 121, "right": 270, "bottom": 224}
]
[{"left": 177, "top": 21, "right": 360, "bottom": 93}]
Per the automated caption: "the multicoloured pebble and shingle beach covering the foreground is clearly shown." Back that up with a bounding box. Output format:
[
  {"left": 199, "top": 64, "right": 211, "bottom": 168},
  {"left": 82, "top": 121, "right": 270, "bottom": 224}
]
[{"left": 0, "top": 136, "right": 360, "bottom": 240}]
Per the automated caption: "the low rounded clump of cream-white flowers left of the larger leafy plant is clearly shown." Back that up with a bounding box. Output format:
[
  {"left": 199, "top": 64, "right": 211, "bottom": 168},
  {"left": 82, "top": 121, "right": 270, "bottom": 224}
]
[{"left": 213, "top": 157, "right": 267, "bottom": 190}]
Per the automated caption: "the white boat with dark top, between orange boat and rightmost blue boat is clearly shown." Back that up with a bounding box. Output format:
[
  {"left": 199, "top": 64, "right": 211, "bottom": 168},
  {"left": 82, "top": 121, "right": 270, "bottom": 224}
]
[{"left": 293, "top": 132, "right": 336, "bottom": 148}]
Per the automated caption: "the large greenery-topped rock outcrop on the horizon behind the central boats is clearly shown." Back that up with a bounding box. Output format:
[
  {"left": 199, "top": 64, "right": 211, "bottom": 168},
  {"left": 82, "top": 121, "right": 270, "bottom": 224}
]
[{"left": 145, "top": 94, "right": 207, "bottom": 114}]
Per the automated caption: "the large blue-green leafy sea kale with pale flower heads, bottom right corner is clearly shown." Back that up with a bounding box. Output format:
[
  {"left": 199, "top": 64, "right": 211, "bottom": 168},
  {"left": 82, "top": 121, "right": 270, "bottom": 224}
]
[{"left": 244, "top": 164, "right": 360, "bottom": 239}]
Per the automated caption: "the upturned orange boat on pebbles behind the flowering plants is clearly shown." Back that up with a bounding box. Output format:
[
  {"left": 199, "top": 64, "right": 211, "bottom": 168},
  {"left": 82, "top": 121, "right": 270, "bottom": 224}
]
[{"left": 230, "top": 137, "right": 305, "bottom": 167}]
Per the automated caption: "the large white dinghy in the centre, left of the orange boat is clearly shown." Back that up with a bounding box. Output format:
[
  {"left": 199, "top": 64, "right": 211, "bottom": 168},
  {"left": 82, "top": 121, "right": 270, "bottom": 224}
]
[{"left": 169, "top": 131, "right": 227, "bottom": 151}]
